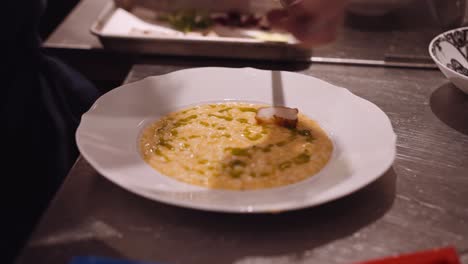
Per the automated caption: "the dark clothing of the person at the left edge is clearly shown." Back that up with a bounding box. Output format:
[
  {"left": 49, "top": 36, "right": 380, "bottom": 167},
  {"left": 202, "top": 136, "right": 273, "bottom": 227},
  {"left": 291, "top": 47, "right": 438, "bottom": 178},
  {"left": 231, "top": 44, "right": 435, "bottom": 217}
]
[{"left": 0, "top": 0, "right": 98, "bottom": 263}]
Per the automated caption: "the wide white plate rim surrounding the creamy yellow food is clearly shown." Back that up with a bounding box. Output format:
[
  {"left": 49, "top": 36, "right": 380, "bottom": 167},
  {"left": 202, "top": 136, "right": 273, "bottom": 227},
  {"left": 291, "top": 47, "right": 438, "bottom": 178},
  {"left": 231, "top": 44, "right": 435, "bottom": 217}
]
[{"left": 76, "top": 68, "right": 396, "bottom": 213}]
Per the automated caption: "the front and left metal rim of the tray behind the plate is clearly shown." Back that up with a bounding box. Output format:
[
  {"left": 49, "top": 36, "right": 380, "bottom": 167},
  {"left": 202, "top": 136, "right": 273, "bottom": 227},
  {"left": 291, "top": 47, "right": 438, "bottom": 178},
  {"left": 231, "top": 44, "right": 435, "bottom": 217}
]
[{"left": 91, "top": 1, "right": 312, "bottom": 61}]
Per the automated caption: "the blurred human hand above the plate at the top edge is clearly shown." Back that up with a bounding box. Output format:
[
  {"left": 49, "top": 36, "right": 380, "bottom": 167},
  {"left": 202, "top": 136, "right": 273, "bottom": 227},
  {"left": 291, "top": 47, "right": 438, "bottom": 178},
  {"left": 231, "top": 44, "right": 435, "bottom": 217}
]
[{"left": 268, "top": 0, "right": 348, "bottom": 48}]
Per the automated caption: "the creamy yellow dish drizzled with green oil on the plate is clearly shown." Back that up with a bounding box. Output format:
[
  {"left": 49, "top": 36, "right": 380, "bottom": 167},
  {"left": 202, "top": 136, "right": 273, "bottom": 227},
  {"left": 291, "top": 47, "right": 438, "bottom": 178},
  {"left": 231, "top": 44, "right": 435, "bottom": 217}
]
[{"left": 139, "top": 103, "right": 333, "bottom": 190}]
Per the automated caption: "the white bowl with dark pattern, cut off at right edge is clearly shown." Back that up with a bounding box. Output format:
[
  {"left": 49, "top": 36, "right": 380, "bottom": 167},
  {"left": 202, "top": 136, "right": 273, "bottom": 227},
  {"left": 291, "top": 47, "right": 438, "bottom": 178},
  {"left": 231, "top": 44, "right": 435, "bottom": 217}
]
[{"left": 429, "top": 27, "right": 468, "bottom": 94}]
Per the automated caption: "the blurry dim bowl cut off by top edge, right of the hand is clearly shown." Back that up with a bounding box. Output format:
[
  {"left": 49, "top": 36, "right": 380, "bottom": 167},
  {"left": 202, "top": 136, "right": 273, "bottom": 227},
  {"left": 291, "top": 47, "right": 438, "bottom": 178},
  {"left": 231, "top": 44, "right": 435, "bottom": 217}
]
[{"left": 348, "top": 0, "right": 413, "bottom": 16}]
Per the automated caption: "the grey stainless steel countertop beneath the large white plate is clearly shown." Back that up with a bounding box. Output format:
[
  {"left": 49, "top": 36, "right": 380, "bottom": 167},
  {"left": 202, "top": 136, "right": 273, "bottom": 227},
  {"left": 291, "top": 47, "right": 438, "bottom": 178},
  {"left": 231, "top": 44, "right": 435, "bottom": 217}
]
[{"left": 17, "top": 59, "right": 468, "bottom": 264}]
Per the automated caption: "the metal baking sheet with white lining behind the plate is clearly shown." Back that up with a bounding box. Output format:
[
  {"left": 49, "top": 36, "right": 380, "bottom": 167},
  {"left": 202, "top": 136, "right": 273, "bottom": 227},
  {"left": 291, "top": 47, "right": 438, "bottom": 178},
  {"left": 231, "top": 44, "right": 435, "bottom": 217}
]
[{"left": 91, "top": 1, "right": 312, "bottom": 61}]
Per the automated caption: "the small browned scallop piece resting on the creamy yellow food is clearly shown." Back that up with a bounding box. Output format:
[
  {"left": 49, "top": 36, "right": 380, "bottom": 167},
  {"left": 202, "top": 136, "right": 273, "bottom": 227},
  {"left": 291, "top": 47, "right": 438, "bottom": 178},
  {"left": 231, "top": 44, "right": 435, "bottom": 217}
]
[{"left": 255, "top": 106, "right": 299, "bottom": 128}]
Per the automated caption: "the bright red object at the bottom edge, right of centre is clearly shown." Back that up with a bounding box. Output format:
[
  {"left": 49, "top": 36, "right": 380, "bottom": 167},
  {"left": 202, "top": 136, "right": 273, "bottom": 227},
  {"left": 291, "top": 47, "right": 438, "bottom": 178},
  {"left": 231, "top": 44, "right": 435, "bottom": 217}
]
[{"left": 357, "top": 247, "right": 460, "bottom": 264}]
